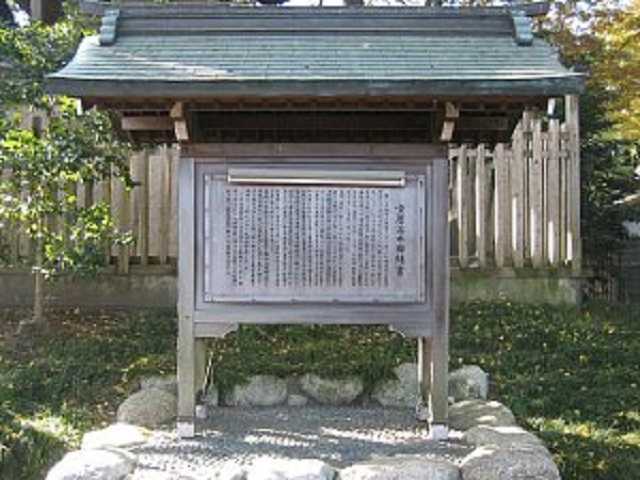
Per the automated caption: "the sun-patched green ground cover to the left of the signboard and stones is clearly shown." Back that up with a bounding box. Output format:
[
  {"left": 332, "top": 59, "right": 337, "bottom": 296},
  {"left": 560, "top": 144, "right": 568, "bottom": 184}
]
[{"left": 0, "top": 311, "right": 176, "bottom": 480}]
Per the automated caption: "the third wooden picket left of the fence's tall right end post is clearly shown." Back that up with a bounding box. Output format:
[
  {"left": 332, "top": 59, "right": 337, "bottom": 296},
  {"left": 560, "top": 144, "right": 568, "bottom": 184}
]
[{"left": 509, "top": 122, "right": 525, "bottom": 268}]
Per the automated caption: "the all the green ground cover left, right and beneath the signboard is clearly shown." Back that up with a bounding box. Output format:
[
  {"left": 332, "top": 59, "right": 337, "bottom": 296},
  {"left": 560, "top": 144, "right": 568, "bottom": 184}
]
[{"left": 0, "top": 302, "right": 640, "bottom": 480}]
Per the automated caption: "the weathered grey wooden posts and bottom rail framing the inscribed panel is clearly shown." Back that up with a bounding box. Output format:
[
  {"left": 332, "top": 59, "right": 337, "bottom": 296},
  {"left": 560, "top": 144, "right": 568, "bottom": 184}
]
[{"left": 177, "top": 150, "right": 449, "bottom": 440}]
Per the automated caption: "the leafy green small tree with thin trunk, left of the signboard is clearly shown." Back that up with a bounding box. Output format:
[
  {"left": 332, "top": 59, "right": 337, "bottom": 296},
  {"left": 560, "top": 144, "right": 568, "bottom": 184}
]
[{"left": 0, "top": 10, "right": 131, "bottom": 325}]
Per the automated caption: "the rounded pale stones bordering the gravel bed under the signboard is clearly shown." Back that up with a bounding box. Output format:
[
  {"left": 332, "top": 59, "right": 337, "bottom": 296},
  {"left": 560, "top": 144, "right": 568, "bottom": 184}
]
[{"left": 46, "top": 364, "right": 560, "bottom": 480}]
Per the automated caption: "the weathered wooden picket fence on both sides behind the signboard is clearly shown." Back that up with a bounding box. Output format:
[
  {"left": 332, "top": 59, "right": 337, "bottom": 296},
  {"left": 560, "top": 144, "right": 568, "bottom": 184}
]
[{"left": 4, "top": 113, "right": 580, "bottom": 274}]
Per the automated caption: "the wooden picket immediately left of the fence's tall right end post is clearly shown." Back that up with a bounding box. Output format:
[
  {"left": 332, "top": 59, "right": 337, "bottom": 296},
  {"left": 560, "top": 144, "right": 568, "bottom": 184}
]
[{"left": 546, "top": 119, "right": 560, "bottom": 267}]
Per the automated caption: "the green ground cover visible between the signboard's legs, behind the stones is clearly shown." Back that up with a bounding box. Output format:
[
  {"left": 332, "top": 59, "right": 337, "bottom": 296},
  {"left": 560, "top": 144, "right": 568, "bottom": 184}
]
[{"left": 212, "top": 325, "right": 415, "bottom": 391}]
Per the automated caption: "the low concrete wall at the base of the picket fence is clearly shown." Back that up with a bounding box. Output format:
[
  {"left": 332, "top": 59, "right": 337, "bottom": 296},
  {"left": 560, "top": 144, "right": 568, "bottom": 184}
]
[{"left": 0, "top": 265, "right": 582, "bottom": 307}]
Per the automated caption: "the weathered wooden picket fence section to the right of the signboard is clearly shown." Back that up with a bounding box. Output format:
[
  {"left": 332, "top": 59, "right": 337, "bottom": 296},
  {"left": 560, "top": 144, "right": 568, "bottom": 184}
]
[{"left": 449, "top": 110, "right": 581, "bottom": 270}]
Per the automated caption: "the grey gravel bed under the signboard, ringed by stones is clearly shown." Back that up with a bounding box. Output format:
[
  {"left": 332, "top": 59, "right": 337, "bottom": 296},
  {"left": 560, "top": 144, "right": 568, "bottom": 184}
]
[{"left": 131, "top": 406, "right": 473, "bottom": 479}]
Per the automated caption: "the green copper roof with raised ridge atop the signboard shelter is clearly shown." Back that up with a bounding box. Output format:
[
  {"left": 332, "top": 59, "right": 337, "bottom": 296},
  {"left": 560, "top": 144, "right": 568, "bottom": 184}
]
[{"left": 50, "top": 7, "right": 582, "bottom": 97}]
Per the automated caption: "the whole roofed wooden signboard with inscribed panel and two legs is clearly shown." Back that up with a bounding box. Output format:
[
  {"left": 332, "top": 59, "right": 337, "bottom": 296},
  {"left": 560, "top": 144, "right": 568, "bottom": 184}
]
[{"left": 49, "top": 2, "right": 582, "bottom": 438}]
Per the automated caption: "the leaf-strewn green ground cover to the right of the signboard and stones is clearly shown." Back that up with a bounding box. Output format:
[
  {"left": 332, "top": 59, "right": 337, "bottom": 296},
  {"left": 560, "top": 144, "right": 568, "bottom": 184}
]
[{"left": 451, "top": 302, "right": 640, "bottom": 480}]
